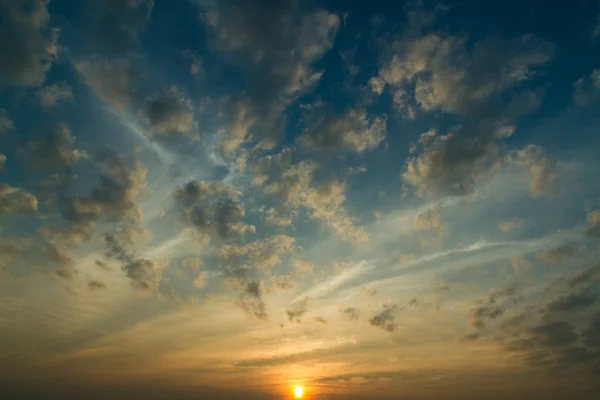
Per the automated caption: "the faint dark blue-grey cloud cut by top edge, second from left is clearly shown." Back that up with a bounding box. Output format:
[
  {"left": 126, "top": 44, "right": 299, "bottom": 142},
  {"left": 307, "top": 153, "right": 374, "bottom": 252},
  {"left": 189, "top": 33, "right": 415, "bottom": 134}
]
[{"left": 85, "top": 0, "right": 154, "bottom": 54}]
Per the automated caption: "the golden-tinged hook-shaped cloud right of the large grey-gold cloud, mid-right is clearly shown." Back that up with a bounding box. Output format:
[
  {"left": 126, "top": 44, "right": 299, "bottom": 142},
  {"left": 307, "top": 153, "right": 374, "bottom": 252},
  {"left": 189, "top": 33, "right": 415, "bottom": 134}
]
[{"left": 507, "top": 145, "right": 557, "bottom": 198}]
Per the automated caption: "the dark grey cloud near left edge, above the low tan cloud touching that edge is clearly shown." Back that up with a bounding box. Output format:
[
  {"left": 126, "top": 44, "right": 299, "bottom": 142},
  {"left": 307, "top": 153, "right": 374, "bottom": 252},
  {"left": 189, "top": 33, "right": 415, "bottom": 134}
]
[{"left": 22, "top": 123, "right": 88, "bottom": 169}]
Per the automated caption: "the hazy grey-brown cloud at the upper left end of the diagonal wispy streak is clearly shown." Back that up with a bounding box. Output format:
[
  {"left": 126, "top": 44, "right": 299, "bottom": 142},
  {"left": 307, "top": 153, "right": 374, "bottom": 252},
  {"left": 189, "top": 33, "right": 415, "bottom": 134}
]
[{"left": 74, "top": 56, "right": 132, "bottom": 111}]
